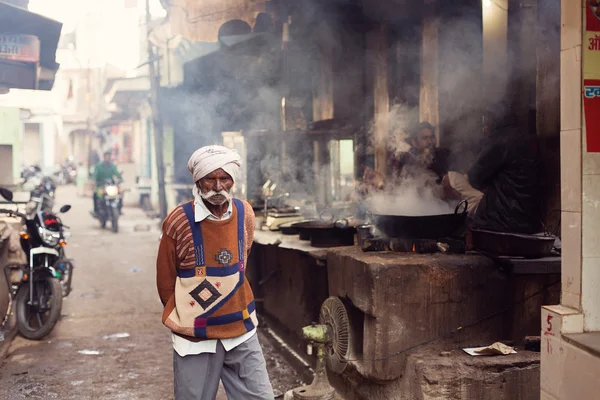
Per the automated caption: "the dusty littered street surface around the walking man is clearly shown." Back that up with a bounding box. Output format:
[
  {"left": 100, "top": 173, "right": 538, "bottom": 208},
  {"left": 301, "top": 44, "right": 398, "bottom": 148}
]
[{"left": 0, "top": 187, "right": 301, "bottom": 400}]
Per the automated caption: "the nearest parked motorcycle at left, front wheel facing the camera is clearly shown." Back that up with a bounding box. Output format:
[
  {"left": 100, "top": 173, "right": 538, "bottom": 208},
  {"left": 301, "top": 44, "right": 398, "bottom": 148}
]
[{"left": 0, "top": 188, "right": 74, "bottom": 340}]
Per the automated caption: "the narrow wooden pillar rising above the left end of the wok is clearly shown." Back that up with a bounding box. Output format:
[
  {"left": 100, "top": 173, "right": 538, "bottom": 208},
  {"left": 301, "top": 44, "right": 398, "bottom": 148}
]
[{"left": 367, "top": 24, "right": 390, "bottom": 176}]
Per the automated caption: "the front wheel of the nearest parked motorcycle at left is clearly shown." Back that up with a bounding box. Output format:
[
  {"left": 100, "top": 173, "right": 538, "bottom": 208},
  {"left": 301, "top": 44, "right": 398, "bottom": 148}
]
[{"left": 15, "top": 277, "right": 62, "bottom": 340}]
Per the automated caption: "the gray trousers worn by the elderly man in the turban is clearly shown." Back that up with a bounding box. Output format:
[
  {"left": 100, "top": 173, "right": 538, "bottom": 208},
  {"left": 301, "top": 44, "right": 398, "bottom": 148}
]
[{"left": 173, "top": 335, "right": 274, "bottom": 400}]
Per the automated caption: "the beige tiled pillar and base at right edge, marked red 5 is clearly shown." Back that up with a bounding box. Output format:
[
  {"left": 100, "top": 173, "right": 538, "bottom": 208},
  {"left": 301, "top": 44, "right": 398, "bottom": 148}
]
[{"left": 541, "top": 0, "right": 600, "bottom": 400}]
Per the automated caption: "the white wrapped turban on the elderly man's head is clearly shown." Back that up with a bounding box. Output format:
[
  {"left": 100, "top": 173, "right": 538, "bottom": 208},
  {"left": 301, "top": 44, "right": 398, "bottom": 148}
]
[{"left": 188, "top": 145, "right": 242, "bottom": 183}]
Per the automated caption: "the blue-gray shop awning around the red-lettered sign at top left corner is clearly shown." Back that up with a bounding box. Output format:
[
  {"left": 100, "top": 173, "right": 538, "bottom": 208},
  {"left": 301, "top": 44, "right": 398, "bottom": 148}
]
[{"left": 0, "top": 1, "right": 62, "bottom": 90}]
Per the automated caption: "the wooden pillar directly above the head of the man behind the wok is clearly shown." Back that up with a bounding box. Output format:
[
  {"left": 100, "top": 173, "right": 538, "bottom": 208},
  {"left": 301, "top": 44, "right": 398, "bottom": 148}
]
[{"left": 419, "top": 0, "right": 439, "bottom": 141}]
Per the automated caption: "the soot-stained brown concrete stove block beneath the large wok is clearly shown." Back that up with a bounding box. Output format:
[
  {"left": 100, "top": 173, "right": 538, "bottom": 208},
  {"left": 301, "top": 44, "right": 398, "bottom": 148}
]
[{"left": 327, "top": 247, "right": 559, "bottom": 382}]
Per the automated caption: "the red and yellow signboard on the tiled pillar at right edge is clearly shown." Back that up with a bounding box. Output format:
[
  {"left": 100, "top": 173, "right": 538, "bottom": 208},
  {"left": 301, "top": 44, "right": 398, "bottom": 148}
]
[{"left": 583, "top": 0, "right": 600, "bottom": 153}]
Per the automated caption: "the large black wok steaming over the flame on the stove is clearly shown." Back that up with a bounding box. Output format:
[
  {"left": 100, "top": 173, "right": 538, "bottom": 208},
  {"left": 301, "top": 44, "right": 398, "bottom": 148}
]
[{"left": 371, "top": 200, "right": 468, "bottom": 239}]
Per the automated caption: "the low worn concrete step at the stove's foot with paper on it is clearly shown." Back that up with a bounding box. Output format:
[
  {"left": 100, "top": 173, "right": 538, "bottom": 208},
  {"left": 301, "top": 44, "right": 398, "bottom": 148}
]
[{"left": 329, "top": 346, "right": 540, "bottom": 400}]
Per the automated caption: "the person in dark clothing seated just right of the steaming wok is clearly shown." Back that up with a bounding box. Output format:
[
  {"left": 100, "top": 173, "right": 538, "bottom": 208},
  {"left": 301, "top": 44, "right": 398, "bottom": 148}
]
[{"left": 442, "top": 104, "right": 540, "bottom": 233}]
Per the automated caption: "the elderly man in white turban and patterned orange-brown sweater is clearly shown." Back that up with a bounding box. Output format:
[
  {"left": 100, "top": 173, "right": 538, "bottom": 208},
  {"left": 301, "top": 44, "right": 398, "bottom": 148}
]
[{"left": 156, "top": 146, "right": 273, "bottom": 400}]
